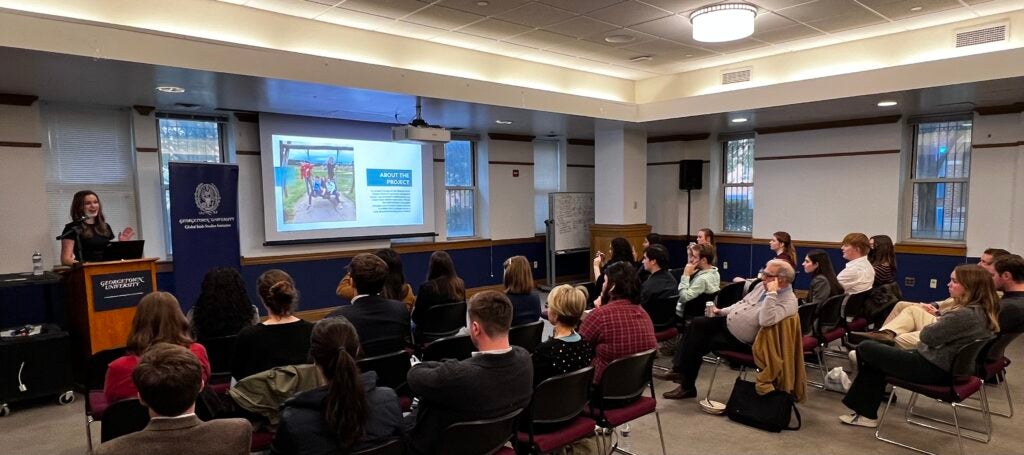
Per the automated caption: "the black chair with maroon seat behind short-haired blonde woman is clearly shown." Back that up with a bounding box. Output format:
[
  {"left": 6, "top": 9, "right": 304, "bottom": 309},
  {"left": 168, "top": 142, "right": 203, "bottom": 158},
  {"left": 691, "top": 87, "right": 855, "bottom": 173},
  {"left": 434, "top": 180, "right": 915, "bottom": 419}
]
[{"left": 516, "top": 367, "right": 596, "bottom": 454}]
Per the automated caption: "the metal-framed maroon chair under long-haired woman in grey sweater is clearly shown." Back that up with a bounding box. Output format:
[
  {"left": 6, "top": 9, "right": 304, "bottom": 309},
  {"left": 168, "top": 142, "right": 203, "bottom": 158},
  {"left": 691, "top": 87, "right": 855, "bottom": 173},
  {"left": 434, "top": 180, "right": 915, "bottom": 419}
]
[{"left": 874, "top": 337, "right": 992, "bottom": 455}]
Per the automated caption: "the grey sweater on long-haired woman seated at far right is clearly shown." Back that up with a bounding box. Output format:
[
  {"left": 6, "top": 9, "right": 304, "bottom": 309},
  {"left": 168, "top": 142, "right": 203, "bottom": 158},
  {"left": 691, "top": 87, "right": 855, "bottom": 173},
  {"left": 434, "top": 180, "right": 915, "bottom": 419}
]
[{"left": 918, "top": 305, "right": 992, "bottom": 371}]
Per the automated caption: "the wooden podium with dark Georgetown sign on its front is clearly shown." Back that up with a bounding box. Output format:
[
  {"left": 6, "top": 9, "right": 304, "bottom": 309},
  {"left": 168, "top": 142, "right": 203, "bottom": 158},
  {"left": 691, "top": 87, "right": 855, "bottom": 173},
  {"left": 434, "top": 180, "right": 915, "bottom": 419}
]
[{"left": 68, "top": 258, "right": 157, "bottom": 361}]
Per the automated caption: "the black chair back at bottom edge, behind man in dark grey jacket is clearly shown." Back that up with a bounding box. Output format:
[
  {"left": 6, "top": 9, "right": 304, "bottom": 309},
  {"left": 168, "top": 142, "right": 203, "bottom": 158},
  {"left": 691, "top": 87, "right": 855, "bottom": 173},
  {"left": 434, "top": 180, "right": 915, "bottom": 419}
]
[{"left": 439, "top": 409, "right": 522, "bottom": 455}]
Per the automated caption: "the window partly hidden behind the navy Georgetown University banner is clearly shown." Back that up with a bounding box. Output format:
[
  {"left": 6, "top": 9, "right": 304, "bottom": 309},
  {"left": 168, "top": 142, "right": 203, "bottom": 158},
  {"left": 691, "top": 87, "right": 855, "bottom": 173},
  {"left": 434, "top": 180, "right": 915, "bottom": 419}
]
[{"left": 157, "top": 114, "right": 226, "bottom": 255}]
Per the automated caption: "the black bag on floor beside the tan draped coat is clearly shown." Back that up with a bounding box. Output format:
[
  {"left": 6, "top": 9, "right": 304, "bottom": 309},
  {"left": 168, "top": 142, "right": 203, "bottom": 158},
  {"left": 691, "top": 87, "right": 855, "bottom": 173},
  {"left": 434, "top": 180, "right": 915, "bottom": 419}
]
[{"left": 725, "top": 378, "right": 803, "bottom": 432}]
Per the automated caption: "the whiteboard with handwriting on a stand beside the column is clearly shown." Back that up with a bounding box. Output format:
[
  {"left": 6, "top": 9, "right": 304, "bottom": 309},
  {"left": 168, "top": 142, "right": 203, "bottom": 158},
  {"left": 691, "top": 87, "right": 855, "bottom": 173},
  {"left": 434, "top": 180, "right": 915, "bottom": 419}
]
[{"left": 548, "top": 193, "right": 594, "bottom": 251}]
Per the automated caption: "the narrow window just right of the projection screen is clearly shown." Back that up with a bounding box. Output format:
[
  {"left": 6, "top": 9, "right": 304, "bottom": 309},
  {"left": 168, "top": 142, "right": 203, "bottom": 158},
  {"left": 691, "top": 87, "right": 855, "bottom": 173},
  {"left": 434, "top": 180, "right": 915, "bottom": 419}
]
[{"left": 444, "top": 140, "right": 476, "bottom": 238}]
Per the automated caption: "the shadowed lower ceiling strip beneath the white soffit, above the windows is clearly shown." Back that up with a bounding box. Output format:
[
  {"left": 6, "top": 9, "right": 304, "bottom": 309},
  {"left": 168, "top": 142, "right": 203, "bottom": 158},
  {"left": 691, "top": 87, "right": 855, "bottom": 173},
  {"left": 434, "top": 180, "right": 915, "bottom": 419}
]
[{"left": 0, "top": 47, "right": 1024, "bottom": 138}]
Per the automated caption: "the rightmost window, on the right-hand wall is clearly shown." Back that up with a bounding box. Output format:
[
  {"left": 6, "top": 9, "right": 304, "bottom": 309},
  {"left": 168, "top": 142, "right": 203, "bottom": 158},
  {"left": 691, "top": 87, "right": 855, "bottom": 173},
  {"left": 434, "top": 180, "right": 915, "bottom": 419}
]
[{"left": 910, "top": 120, "right": 972, "bottom": 241}]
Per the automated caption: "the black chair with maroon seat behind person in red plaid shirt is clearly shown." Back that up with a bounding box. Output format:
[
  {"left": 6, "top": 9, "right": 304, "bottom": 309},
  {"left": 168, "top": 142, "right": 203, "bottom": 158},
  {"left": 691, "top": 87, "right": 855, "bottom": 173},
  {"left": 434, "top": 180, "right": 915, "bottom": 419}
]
[{"left": 586, "top": 349, "right": 667, "bottom": 454}]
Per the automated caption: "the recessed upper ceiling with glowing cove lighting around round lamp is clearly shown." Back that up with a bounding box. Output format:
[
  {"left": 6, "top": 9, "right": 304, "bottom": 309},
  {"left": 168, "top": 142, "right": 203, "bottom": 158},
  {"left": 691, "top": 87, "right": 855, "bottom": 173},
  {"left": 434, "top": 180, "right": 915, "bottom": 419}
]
[{"left": 211, "top": 0, "right": 1022, "bottom": 80}]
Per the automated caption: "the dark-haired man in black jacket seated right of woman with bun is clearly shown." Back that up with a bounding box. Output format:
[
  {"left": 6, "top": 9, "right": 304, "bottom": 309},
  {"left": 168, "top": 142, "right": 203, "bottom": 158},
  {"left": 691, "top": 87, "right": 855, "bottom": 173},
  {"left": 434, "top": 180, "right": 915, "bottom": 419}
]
[{"left": 328, "top": 253, "right": 410, "bottom": 357}]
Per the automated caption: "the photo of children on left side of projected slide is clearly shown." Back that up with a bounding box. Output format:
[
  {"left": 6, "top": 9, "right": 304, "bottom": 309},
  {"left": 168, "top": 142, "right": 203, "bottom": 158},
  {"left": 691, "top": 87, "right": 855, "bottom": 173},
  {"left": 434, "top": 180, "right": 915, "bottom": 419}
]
[{"left": 278, "top": 140, "right": 355, "bottom": 224}]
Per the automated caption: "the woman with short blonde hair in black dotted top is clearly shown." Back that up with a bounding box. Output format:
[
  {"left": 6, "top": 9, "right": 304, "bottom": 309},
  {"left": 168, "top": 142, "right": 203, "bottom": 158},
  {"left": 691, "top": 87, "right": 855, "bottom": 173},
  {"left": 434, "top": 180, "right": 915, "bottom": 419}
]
[{"left": 534, "top": 285, "right": 594, "bottom": 384}]
